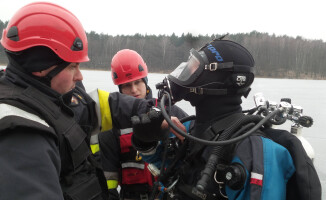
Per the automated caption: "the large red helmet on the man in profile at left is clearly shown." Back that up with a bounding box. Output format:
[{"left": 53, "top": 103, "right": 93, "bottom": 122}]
[{"left": 1, "top": 2, "right": 89, "bottom": 62}]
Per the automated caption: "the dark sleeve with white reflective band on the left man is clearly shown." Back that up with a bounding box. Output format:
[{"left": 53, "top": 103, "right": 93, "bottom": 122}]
[{"left": 0, "top": 70, "right": 68, "bottom": 199}]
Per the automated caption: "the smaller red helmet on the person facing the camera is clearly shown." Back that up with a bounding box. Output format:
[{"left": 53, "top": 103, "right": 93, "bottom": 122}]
[{"left": 111, "top": 49, "right": 148, "bottom": 85}]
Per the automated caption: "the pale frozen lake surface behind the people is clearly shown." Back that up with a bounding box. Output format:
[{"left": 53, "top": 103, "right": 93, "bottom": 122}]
[{"left": 83, "top": 70, "right": 326, "bottom": 199}]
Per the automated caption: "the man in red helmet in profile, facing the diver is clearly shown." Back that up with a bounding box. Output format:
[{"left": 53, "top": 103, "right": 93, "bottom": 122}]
[{"left": 0, "top": 2, "right": 188, "bottom": 200}]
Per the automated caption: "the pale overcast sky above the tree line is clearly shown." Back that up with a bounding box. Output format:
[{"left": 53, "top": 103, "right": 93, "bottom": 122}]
[{"left": 0, "top": 0, "right": 326, "bottom": 42}]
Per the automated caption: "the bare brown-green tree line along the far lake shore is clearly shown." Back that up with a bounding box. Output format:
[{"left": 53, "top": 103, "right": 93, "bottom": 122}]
[{"left": 0, "top": 20, "right": 326, "bottom": 79}]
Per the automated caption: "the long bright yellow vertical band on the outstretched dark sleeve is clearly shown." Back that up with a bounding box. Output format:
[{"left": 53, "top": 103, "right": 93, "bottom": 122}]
[{"left": 98, "top": 89, "right": 112, "bottom": 132}]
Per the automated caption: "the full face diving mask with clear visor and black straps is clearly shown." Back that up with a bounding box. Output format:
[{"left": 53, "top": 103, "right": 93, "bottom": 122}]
[{"left": 156, "top": 46, "right": 253, "bottom": 103}]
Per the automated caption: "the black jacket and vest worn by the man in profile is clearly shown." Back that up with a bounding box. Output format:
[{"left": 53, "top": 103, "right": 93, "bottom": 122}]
[{"left": 0, "top": 65, "right": 155, "bottom": 199}]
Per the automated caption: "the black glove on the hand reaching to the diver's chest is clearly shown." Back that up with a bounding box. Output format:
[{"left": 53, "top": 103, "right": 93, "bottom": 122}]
[{"left": 131, "top": 108, "right": 168, "bottom": 143}]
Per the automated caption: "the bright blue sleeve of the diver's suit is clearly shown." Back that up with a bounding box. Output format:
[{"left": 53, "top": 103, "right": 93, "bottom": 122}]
[{"left": 226, "top": 137, "right": 295, "bottom": 200}]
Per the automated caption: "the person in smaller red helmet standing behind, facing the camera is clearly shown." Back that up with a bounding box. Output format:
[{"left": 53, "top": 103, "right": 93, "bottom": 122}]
[{"left": 99, "top": 49, "right": 188, "bottom": 200}]
